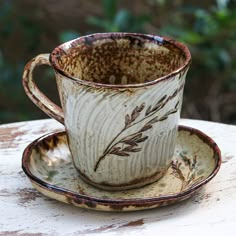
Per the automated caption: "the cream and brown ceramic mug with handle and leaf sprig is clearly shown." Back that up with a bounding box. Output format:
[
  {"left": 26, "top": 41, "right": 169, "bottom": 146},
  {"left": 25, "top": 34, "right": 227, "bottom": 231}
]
[{"left": 23, "top": 33, "right": 191, "bottom": 190}]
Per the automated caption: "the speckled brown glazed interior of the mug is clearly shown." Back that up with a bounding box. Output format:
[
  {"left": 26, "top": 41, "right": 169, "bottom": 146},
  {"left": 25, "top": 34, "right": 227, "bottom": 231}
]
[{"left": 50, "top": 33, "right": 189, "bottom": 86}]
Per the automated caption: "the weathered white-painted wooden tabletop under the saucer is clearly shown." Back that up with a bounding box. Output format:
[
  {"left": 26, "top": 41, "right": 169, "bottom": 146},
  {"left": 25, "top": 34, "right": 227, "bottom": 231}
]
[{"left": 0, "top": 119, "right": 236, "bottom": 236}]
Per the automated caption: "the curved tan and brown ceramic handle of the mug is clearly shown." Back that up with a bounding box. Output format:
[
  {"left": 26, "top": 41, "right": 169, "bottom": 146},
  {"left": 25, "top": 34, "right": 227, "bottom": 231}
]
[{"left": 22, "top": 53, "right": 64, "bottom": 124}]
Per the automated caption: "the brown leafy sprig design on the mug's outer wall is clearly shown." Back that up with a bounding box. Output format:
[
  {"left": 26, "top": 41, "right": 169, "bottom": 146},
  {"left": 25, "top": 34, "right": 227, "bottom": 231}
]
[{"left": 94, "top": 85, "right": 184, "bottom": 171}]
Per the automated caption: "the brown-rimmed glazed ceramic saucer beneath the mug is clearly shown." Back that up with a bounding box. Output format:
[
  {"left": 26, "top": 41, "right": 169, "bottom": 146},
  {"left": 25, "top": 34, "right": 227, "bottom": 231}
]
[{"left": 22, "top": 126, "right": 221, "bottom": 211}]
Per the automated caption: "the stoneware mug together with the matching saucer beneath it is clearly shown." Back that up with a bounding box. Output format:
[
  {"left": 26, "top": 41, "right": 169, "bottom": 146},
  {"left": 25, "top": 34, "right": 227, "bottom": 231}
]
[{"left": 22, "top": 33, "right": 221, "bottom": 211}]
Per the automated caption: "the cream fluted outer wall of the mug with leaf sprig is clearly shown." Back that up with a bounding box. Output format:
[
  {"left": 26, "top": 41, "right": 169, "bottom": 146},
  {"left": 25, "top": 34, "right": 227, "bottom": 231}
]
[{"left": 57, "top": 71, "right": 185, "bottom": 189}]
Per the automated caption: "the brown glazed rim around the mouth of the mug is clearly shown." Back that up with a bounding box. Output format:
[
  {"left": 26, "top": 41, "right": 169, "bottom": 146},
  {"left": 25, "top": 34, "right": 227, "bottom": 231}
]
[{"left": 49, "top": 32, "right": 191, "bottom": 88}]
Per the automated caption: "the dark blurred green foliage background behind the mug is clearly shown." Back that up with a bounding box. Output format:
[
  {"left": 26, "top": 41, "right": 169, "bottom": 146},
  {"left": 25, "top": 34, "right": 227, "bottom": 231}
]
[{"left": 0, "top": 0, "right": 236, "bottom": 124}]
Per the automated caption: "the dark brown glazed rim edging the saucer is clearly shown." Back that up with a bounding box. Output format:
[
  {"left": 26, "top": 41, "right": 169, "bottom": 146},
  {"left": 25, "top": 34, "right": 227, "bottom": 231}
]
[{"left": 22, "top": 125, "right": 222, "bottom": 210}]
